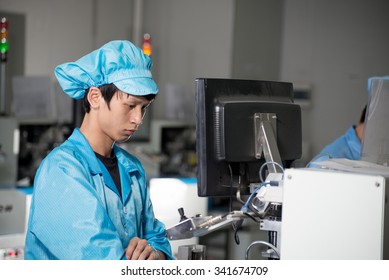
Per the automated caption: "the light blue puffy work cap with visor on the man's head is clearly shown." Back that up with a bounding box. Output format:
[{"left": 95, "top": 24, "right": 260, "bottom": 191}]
[{"left": 54, "top": 41, "right": 158, "bottom": 99}]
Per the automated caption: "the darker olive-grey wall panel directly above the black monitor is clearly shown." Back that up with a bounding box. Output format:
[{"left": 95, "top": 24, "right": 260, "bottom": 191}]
[{"left": 232, "top": 0, "right": 285, "bottom": 81}]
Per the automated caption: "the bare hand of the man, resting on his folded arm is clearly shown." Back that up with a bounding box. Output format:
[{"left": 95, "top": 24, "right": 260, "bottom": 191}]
[{"left": 126, "top": 237, "right": 165, "bottom": 260}]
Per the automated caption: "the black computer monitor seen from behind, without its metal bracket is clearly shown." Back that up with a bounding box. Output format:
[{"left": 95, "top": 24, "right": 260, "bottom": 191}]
[{"left": 195, "top": 78, "right": 302, "bottom": 197}]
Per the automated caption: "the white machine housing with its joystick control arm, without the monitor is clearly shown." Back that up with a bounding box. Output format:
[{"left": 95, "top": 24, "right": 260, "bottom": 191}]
[{"left": 167, "top": 163, "right": 389, "bottom": 260}]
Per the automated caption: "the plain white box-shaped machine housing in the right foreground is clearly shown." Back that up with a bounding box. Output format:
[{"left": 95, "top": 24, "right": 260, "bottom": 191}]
[{"left": 280, "top": 168, "right": 389, "bottom": 260}]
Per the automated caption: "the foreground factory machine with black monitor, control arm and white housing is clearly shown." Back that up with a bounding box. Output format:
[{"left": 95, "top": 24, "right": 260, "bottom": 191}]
[{"left": 167, "top": 79, "right": 389, "bottom": 260}]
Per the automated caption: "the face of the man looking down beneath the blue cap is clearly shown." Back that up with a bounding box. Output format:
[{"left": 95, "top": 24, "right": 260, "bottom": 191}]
[{"left": 99, "top": 91, "right": 150, "bottom": 142}]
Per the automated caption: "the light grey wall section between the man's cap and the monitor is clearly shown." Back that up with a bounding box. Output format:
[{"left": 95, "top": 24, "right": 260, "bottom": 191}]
[{"left": 143, "top": 0, "right": 234, "bottom": 119}]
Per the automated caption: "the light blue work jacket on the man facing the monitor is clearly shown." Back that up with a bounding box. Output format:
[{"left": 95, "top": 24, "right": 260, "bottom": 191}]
[{"left": 25, "top": 129, "right": 173, "bottom": 260}]
